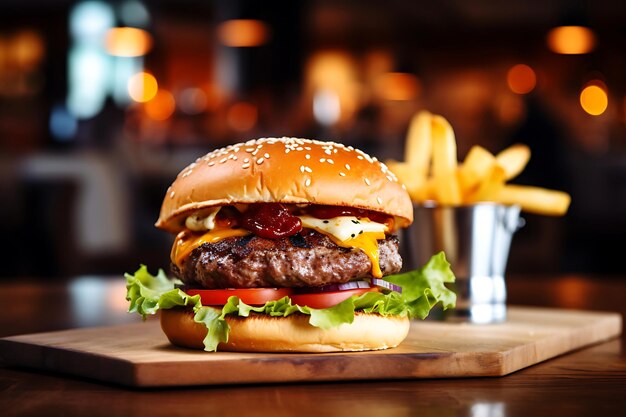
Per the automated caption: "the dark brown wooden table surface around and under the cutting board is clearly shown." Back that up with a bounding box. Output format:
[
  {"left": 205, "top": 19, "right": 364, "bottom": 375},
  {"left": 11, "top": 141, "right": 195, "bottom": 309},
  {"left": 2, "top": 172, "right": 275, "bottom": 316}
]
[{"left": 0, "top": 275, "right": 626, "bottom": 417}]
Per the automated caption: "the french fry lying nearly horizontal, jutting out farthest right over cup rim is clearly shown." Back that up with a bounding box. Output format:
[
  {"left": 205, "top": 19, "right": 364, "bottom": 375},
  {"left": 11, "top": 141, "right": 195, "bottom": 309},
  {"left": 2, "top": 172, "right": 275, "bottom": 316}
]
[{"left": 493, "top": 185, "right": 571, "bottom": 216}]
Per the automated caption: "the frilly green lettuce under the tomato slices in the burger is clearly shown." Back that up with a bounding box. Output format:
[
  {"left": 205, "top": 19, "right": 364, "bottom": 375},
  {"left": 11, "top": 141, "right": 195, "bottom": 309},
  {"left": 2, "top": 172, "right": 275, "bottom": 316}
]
[{"left": 125, "top": 252, "right": 456, "bottom": 351}]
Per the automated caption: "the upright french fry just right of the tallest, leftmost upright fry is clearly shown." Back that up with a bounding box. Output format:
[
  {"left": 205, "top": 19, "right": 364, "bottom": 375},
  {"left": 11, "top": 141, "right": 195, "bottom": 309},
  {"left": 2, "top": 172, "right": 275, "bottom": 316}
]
[{"left": 431, "top": 116, "right": 461, "bottom": 205}]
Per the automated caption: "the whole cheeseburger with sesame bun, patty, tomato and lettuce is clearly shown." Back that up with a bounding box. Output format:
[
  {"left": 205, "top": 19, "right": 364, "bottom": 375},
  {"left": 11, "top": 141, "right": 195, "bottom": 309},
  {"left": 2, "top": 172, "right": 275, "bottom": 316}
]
[{"left": 126, "top": 138, "right": 455, "bottom": 352}]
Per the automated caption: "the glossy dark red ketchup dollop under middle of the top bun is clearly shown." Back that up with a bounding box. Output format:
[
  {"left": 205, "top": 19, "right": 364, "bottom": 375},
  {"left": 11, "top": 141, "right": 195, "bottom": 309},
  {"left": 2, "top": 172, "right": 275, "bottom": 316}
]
[{"left": 239, "top": 203, "right": 302, "bottom": 239}]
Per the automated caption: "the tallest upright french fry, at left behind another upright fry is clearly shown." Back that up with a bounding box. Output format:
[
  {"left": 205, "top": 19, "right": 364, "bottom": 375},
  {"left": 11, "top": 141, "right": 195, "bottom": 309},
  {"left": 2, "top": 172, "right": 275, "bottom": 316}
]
[{"left": 404, "top": 111, "right": 433, "bottom": 181}]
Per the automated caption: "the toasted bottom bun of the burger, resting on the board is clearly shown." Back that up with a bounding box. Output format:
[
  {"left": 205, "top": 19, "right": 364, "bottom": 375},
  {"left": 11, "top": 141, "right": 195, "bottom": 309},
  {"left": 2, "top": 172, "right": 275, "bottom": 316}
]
[{"left": 161, "top": 309, "right": 410, "bottom": 352}]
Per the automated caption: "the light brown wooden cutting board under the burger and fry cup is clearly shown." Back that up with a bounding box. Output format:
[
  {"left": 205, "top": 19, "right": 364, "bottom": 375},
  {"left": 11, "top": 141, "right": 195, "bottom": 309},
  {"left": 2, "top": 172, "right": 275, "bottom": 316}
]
[{"left": 0, "top": 307, "right": 622, "bottom": 387}]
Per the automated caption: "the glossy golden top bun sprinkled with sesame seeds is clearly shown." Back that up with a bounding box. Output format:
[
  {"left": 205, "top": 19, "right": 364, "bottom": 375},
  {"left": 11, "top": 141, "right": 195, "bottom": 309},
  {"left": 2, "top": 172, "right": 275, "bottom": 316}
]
[{"left": 156, "top": 138, "right": 413, "bottom": 233}]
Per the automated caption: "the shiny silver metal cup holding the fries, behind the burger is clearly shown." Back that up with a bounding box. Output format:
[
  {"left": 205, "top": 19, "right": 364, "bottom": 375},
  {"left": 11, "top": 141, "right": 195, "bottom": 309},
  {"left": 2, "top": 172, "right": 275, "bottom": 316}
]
[{"left": 404, "top": 203, "right": 521, "bottom": 323}]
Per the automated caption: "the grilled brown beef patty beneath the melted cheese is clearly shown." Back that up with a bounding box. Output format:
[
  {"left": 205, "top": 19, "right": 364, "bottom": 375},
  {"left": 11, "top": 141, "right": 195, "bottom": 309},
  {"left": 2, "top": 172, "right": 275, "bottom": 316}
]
[{"left": 172, "top": 229, "right": 402, "bottom": 288}]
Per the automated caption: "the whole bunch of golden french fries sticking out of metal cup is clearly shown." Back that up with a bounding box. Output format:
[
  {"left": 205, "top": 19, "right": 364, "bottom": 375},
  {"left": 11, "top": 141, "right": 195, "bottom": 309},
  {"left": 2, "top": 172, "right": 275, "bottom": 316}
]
[{"left": 387, "top": 111, "right": 571, "bottom": 216}]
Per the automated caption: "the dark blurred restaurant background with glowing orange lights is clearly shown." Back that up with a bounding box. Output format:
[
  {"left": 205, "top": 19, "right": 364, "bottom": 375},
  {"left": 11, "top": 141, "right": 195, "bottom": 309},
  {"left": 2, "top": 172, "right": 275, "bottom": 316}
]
[{"left": 0, "top": 0, "right": 626, "bottom": 278}]
